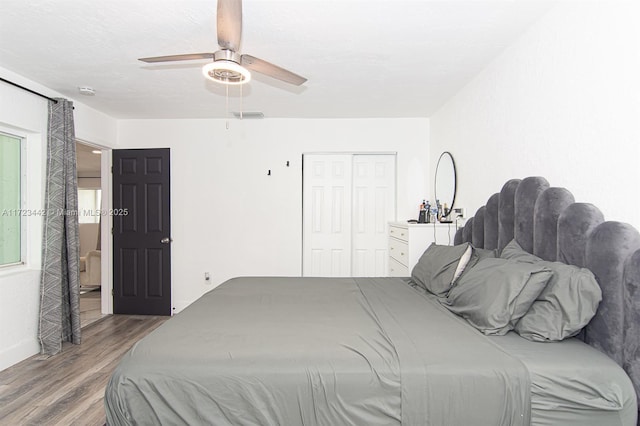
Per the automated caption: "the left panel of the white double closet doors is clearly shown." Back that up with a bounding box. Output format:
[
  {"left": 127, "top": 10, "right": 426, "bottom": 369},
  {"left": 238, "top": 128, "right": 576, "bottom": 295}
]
[{"left": 302, "top": 154, "right": 352, "bottom": 277}]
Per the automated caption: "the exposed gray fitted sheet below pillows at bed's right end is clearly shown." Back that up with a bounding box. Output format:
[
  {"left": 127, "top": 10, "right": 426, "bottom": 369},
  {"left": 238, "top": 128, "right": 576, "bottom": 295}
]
[{"left": 489, "top": 332, "right": 638, "bottom": 426}]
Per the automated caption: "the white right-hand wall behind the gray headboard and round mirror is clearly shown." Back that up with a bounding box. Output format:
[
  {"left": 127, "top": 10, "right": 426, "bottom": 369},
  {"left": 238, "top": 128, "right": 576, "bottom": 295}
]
[{"left": 430, "top": 1, "right": 640, "bottom": 228}]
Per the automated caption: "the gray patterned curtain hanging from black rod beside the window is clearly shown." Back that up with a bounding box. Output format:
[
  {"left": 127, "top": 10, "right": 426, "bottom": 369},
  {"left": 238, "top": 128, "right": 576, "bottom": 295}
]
[{"left": 38, "top": 99, "right": 80, "bottom": 355}]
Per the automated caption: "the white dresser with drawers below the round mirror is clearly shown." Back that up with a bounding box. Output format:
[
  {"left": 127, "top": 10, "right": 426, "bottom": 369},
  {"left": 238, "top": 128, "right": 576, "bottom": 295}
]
[{"left": 389, "top": 222, "right": 456, "bottom": 277}]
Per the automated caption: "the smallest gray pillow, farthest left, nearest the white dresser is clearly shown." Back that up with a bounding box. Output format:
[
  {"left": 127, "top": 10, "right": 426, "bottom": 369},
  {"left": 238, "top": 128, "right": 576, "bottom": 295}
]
[{"left": 411, "top": 243, "right": 472, "bottom": 297}]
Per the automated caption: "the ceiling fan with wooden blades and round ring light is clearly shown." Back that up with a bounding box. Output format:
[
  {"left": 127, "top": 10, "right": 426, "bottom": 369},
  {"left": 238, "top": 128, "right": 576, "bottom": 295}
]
[{"left": 139, "top": 0, "right": 307, "bottom": 86}]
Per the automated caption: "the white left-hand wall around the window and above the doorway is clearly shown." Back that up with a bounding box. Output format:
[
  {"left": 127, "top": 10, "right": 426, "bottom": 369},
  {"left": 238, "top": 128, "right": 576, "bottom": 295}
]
[{"left": 0, "top": 68, "right": 116, "bottom": 370}]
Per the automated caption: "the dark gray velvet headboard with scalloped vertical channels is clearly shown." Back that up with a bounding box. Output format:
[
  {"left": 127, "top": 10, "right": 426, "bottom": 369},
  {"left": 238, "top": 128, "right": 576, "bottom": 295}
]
[{"left": 455, "top": 177, "right": 640, "bottom": 414}]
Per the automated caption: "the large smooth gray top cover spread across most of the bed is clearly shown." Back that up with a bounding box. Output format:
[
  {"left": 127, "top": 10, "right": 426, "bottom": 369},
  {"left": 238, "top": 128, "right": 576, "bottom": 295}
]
[{"left": 105, "top": 277, "right": 531, "bottom": 426}]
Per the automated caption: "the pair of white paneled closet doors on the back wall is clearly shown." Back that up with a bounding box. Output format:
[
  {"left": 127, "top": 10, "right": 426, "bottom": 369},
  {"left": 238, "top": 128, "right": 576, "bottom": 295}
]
[{"left": 302, "top": 154, "right": 395, "bottom": 277}]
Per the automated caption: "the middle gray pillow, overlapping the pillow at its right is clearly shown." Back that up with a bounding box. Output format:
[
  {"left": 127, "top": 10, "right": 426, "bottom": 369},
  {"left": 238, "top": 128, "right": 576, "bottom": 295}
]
[{"left": 441, "top": 258, "right": 552, "bottom": 335}]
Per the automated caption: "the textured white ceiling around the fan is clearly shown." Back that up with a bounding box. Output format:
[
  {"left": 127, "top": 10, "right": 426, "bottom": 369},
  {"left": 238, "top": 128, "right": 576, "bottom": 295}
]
[{"left": 0, "top": 0, "right": 555, "bottom": 118}]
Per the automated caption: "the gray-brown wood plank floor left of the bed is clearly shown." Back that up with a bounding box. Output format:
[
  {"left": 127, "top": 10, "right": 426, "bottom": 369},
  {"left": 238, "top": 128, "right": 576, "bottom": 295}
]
[{"left": 0, "top": 315, "right": 169, "bottom": 426}]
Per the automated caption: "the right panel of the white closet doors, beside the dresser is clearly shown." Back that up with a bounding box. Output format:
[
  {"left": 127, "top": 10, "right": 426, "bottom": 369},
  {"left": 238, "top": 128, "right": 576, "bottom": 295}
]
[{"left": 351, "top": 155, "right": 396, "bottom": 277}]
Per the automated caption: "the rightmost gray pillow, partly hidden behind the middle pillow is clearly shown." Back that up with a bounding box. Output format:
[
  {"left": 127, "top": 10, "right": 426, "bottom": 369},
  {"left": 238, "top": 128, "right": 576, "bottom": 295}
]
[{"left": 501, "top": 241, "right": 602, "bottom": 342}]
